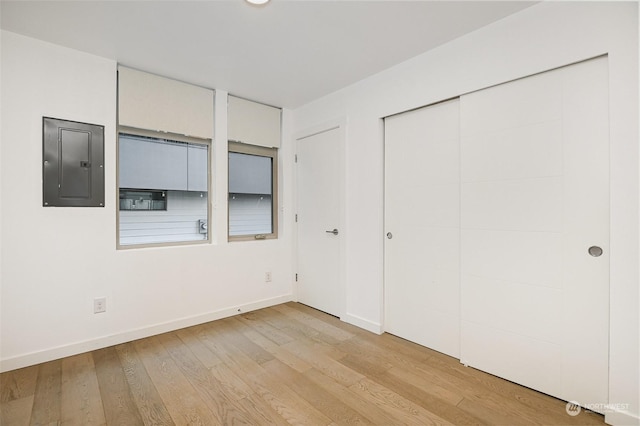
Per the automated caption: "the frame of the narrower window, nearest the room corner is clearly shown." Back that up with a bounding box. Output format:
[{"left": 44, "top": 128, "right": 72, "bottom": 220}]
[{"left": 227, "top": 140, "right": 278, "bottom": 242}]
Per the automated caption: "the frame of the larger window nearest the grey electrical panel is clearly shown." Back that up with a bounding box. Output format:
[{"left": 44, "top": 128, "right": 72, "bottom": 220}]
[{"left": 115, "top": 126, "right": 213, "bottom": 250}]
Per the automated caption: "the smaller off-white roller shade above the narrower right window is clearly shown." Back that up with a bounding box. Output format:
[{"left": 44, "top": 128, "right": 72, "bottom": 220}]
[{"left": 228, "top": 96, "right": 281, "bottom": 148}]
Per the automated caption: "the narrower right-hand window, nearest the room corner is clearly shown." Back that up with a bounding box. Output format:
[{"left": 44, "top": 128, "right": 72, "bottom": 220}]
[{"left": 229, "top": 142, "right": 278, "bottom": 241}]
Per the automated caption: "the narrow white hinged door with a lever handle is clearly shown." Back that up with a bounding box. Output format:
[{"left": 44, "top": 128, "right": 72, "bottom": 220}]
[{"left": 297, "top": 127, "right": 344, "bottom": 317}]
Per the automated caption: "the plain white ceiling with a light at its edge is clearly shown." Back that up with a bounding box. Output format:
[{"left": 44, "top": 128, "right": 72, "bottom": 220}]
[{"left": 0, "top": 0, "right": 533, "bottom": 108}]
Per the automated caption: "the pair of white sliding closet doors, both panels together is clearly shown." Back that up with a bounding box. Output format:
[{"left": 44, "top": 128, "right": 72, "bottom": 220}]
[{"left": 385, "top": 58, "right": 609, "bottom": 410}]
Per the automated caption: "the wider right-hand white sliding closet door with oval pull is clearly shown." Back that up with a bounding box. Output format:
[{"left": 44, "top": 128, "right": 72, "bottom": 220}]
[{"left": 460, "top": 58, "right": 609, "bottom": 403}]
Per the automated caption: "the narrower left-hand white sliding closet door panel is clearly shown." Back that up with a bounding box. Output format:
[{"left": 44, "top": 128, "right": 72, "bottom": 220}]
[{"left": 385, "top": 100, "right": 460, "bottom": 358}]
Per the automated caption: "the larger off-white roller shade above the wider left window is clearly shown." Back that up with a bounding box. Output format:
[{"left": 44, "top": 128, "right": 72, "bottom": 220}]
[{"left": 118, "top": 67, "right": 213, "bottom": 139}]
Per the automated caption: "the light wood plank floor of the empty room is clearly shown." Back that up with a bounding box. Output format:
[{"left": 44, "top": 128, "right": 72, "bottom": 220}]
[{"left": 0, "top": 303, "right": 604, "bottom": 426}]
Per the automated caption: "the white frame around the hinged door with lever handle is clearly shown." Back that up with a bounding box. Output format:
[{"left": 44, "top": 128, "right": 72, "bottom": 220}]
[{"left": 292, "top": 117, "right": 349, "bottom": 320}]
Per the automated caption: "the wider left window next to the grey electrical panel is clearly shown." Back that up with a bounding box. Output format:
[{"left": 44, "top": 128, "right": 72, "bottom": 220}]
[{"left": 118, "top": 131, "right": 210, "bottom": 247}]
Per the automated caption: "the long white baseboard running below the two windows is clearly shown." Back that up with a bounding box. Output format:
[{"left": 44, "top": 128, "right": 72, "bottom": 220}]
[{"left": 0, "top": 294, "right": 292, "bottom": 372}]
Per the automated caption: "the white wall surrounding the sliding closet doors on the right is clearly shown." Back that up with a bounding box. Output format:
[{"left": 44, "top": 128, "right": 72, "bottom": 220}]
[{"left": 293, "top": 2, "right": 640, "bottom": 424}]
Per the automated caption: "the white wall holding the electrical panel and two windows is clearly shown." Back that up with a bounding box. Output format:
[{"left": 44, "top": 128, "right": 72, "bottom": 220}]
[{"left": 0, "top": 31, "right": 293, "bottom": 371}]
